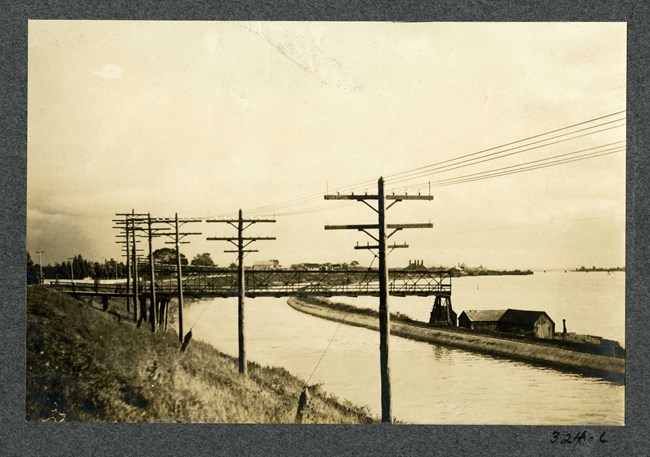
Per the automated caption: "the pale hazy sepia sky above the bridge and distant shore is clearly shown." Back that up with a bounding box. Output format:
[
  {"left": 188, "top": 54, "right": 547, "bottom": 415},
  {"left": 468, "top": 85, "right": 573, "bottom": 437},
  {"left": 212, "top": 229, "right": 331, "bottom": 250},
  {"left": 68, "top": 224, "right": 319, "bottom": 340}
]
[{"left": 27, "top": 20, "right": 626, "bottom": 269}]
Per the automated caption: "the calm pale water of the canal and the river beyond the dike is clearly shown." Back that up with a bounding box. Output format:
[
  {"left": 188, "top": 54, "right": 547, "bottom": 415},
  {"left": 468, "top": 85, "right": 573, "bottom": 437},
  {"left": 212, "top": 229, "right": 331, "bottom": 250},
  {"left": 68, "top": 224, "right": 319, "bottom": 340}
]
[{"left": 186, "top": 273, "right": 625, "bottom": 425}]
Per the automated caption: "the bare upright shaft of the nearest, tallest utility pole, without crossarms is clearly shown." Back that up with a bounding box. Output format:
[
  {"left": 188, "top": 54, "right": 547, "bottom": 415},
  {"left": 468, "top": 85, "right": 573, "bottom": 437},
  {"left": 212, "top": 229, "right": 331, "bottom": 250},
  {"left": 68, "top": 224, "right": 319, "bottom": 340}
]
[{"left": 377, "top": 178, "right": 392, "bottom": 423}]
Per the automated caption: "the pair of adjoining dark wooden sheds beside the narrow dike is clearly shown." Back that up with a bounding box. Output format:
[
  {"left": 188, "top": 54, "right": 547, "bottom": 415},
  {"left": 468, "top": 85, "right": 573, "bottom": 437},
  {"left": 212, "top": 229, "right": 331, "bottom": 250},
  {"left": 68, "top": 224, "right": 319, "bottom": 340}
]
[{"left": 458, "top": 309, "right": 555, "bottom": 338}]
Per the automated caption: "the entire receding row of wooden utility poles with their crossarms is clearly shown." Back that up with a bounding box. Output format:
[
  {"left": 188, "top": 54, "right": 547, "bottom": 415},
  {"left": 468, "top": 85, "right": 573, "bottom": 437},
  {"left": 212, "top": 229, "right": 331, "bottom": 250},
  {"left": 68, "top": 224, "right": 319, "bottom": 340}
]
[{"left": 109, "top": 178, "right": 433, "bottom": 422}]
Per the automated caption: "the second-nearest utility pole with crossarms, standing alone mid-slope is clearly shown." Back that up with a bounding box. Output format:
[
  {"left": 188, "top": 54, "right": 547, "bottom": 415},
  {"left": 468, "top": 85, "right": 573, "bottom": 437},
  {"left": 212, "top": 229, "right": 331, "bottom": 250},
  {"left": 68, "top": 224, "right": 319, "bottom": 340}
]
[{"left": 207, "top": 209, "right": 275, "bottom": 376}]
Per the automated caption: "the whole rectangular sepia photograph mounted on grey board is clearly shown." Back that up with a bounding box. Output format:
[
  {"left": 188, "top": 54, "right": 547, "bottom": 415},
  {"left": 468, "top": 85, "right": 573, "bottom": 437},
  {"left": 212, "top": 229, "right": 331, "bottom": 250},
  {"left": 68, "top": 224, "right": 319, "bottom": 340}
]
[{"left": 25, "top": 19, "right": 627, "bottom": 424}]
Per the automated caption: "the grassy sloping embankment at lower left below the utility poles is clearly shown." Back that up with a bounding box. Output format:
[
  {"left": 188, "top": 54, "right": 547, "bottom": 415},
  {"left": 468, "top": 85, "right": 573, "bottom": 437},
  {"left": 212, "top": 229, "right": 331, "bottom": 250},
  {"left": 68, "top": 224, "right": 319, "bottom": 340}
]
[{"left": 26, "top": 287, "right": 376, "bottom": 423}]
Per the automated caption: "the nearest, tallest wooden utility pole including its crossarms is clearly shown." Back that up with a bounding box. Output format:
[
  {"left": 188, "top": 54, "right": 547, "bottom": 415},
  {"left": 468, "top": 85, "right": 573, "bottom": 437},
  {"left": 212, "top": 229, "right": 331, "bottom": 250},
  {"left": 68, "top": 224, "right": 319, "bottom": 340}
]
[{"left": 325, "top": 178, "right": 433, "bottom": 423}]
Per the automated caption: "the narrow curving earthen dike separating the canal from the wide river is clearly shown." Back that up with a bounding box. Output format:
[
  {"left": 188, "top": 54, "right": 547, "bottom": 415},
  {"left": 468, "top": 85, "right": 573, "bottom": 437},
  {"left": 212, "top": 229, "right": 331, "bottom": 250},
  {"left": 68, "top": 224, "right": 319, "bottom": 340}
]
[{"left": 287, "top": 297, "right": 625, "bottom": 384}]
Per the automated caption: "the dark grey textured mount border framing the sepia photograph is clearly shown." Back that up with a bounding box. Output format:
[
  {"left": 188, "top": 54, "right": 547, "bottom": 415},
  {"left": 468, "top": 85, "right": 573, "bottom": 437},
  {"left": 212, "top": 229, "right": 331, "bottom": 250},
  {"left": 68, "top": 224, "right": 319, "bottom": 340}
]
[{"left": 0, "top": 0, "right": 650, "bottom": 456}]
